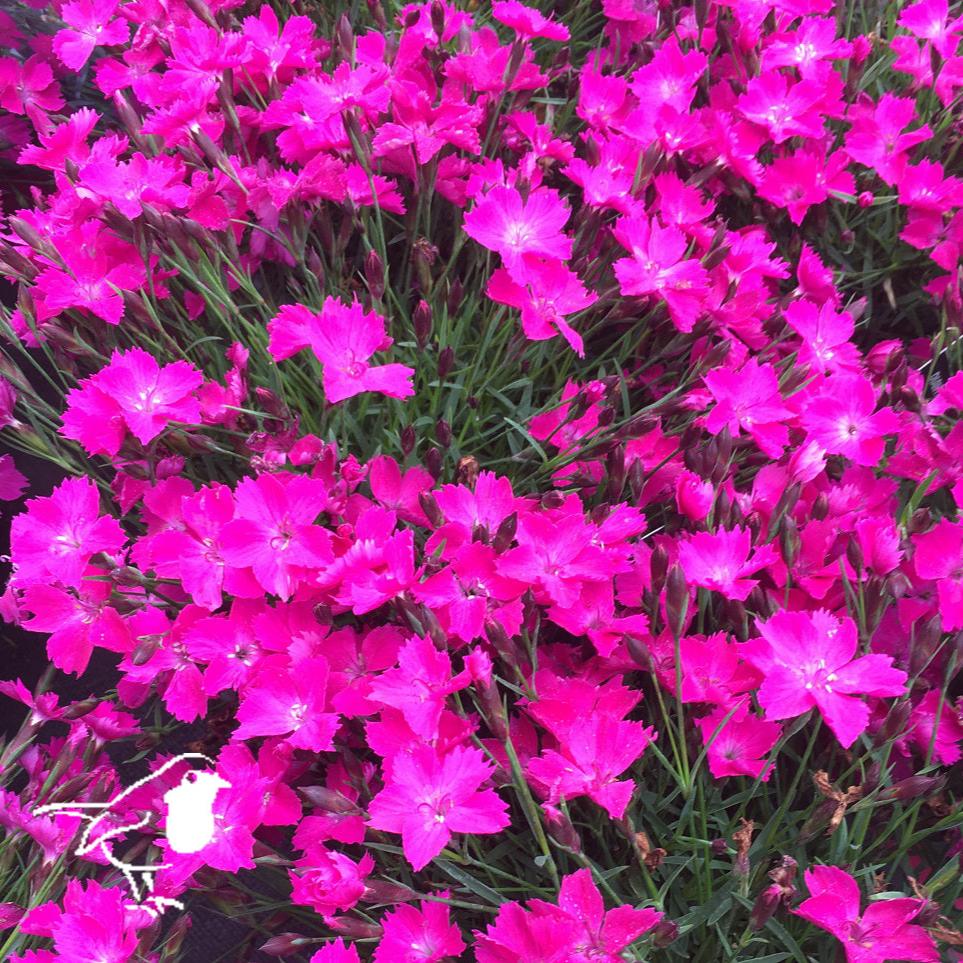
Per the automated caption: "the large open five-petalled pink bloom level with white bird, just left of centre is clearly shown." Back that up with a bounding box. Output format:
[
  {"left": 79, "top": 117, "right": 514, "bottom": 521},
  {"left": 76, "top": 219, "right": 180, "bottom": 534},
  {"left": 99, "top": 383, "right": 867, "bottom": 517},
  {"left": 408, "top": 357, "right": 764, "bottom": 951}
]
[{"left": 368, "top": 746, "right": 509, "bottom": 870}]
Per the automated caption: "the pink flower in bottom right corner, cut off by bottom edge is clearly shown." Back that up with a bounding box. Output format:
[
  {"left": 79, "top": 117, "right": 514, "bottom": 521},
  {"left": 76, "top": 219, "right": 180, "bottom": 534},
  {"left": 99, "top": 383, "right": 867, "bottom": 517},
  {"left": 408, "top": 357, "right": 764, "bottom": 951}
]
[{"left": 793, "top": 866, "right": 940, "bottom": 963}]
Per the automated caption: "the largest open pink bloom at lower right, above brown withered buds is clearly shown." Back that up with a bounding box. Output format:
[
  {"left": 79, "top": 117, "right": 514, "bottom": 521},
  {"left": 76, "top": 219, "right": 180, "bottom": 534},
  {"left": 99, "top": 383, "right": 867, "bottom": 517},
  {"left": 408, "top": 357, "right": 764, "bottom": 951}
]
[{"left": 741, "top": 609, "right": 906, "bottom": 749}]
